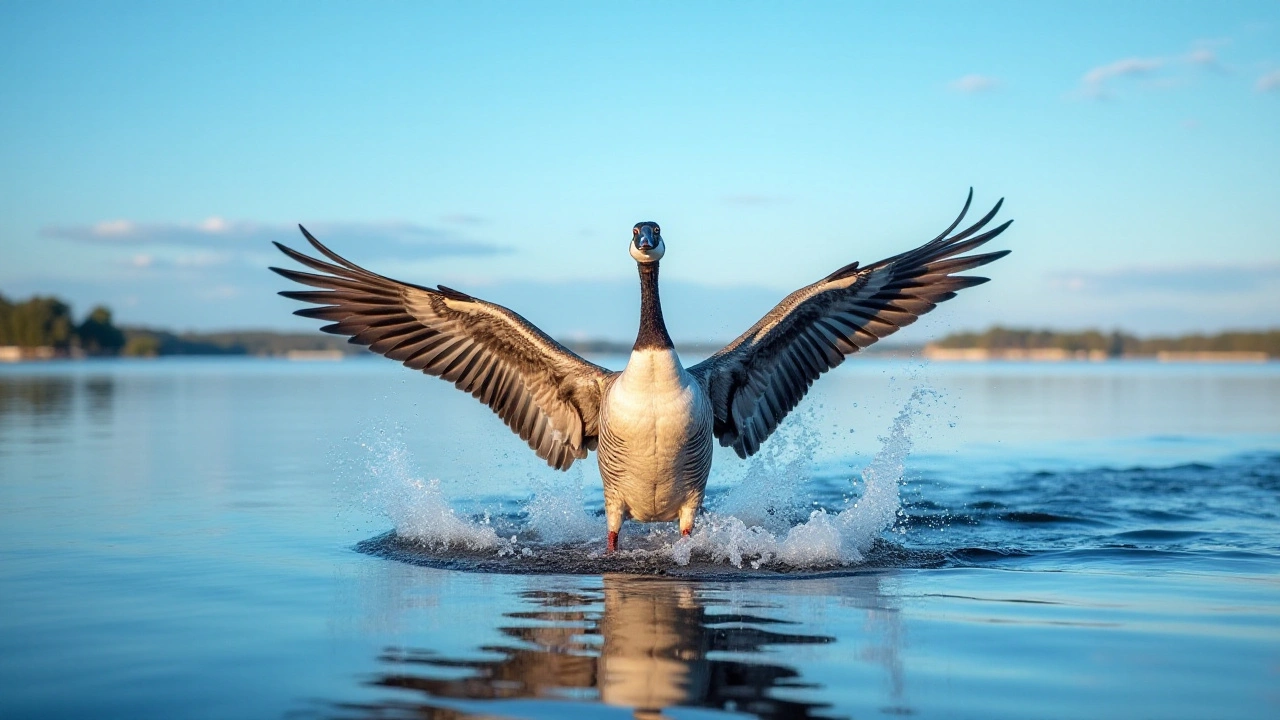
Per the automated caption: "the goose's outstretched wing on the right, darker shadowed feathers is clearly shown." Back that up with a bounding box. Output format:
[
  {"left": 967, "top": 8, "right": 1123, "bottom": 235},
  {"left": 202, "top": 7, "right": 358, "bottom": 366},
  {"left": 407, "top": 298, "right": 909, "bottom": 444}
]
[{"left": 690, "top": 188, "right": 1012, "bottom": 457}]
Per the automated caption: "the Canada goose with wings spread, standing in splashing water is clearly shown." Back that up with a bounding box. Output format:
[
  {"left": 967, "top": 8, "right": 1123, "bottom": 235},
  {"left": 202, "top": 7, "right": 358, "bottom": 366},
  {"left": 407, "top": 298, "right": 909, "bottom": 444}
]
[{"left": 271, "top": 188, "right": 1012, "bottom": 552}]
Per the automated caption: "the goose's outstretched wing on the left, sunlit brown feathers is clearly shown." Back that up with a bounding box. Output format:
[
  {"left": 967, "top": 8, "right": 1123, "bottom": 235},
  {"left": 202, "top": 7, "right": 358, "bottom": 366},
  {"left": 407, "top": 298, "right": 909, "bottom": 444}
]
[{"left": 271, "top": 225, "right": 609, "bottom": 470}]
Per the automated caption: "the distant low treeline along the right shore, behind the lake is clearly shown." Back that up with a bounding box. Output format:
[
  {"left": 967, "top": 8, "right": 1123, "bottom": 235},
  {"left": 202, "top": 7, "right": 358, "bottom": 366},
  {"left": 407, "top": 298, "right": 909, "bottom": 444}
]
[{"left": 933, "top": 325, "right": 1280, "bottom": 357}]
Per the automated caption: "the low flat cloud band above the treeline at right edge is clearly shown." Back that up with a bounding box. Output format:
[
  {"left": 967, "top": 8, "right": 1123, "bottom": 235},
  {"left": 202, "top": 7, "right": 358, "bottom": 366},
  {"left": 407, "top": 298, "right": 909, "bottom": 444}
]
[{"left": 1052, "top": 263, "right": 1280, "bottom": 295}]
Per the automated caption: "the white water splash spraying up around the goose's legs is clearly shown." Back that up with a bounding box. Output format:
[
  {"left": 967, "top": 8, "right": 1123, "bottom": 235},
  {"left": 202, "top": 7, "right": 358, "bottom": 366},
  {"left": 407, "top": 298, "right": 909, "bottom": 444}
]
[{"left": 361, "top": 387, "right": 937, "bottom": 573}]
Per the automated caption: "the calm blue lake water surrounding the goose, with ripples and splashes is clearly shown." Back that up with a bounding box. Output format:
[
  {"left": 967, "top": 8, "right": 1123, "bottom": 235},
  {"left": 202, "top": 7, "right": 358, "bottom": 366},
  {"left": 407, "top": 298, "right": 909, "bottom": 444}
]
[{"left": 0, "top": 357, "right": 1280, "bottom": 719}]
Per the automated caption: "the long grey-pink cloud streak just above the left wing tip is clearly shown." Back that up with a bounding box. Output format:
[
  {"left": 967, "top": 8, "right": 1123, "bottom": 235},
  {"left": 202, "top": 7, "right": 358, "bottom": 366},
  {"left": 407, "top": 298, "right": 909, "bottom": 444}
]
[{"left": 41, "top": 217, "right": 507, "bottom": 258}]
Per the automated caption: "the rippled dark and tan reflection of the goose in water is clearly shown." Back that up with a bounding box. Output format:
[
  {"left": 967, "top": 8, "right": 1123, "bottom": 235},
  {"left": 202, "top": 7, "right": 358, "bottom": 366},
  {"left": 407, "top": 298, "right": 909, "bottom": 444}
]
[{"left": 342, "top": 575, "right": 835, "bottom": 719}]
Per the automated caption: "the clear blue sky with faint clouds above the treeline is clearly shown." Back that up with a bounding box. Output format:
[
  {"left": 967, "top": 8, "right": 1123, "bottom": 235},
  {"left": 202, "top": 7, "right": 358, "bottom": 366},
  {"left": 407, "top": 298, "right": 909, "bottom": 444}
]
[{"left": 0, "top": 1, "right": 1280, "bottom": 341}]
